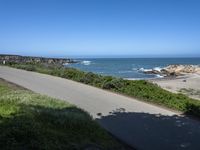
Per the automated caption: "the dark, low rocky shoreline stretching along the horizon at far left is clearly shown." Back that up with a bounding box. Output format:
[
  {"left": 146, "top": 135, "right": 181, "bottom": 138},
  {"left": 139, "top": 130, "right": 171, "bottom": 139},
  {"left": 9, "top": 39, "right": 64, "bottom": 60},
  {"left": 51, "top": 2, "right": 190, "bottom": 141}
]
[{"left": 0, "top": 55, "right": 76, "bottom": 65}]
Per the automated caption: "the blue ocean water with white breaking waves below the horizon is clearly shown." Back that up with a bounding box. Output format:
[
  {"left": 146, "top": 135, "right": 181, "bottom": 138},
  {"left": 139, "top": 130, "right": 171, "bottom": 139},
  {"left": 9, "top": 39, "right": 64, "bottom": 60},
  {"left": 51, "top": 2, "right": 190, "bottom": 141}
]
[{"left": 67, "top": 58, "right": 200, "bottom": 79}]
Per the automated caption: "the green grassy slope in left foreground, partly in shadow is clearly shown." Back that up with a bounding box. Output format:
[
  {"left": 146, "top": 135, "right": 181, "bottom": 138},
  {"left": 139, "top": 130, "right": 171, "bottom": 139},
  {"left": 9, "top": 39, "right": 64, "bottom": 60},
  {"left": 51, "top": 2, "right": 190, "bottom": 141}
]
[{"left": 0, "top": 80, "right": 123, "bottom": 150}]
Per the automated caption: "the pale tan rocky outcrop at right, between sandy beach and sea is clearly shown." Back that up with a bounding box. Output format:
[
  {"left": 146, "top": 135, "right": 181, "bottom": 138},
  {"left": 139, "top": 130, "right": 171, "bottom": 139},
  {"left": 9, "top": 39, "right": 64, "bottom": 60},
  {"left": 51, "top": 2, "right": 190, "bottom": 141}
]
[{"left": 144, "top": 65, "right": 200, "bottom": 76}]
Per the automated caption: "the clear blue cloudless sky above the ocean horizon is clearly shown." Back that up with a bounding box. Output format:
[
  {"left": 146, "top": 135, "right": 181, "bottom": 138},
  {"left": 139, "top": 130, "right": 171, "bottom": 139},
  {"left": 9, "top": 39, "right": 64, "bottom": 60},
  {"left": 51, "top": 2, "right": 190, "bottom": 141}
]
[{"left": 0, "top": 0, "right": 200, "bottom": 57}]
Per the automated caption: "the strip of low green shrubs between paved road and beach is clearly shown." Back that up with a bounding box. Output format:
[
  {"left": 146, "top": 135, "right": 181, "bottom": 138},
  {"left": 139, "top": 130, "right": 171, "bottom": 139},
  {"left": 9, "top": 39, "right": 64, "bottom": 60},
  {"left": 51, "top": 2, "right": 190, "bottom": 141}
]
[{"left": 4, "top": 63, "right": 200, "bottom": 117}]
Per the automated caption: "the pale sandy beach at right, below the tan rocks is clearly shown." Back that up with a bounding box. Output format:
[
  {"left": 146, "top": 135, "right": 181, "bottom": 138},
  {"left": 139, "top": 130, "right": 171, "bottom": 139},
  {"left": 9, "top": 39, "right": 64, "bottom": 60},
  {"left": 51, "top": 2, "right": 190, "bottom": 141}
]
[{"left": 152, "top": 73, "right": 200, "bottom": 100}]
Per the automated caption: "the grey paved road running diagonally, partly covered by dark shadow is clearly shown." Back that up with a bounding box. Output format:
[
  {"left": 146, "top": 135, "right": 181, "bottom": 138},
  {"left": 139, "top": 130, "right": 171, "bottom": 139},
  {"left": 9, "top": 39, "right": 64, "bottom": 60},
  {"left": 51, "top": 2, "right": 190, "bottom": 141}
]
[{"left": 0, "top": 66, "right": 200, "bottom": 150}]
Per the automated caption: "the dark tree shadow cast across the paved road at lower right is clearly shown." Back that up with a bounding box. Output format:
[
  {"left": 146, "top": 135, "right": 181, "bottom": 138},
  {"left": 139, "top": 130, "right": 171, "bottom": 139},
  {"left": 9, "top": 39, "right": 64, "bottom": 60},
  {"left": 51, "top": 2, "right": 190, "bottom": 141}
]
[{"left": 97, "top": 108, "right": 200, "bottom": 150}]
